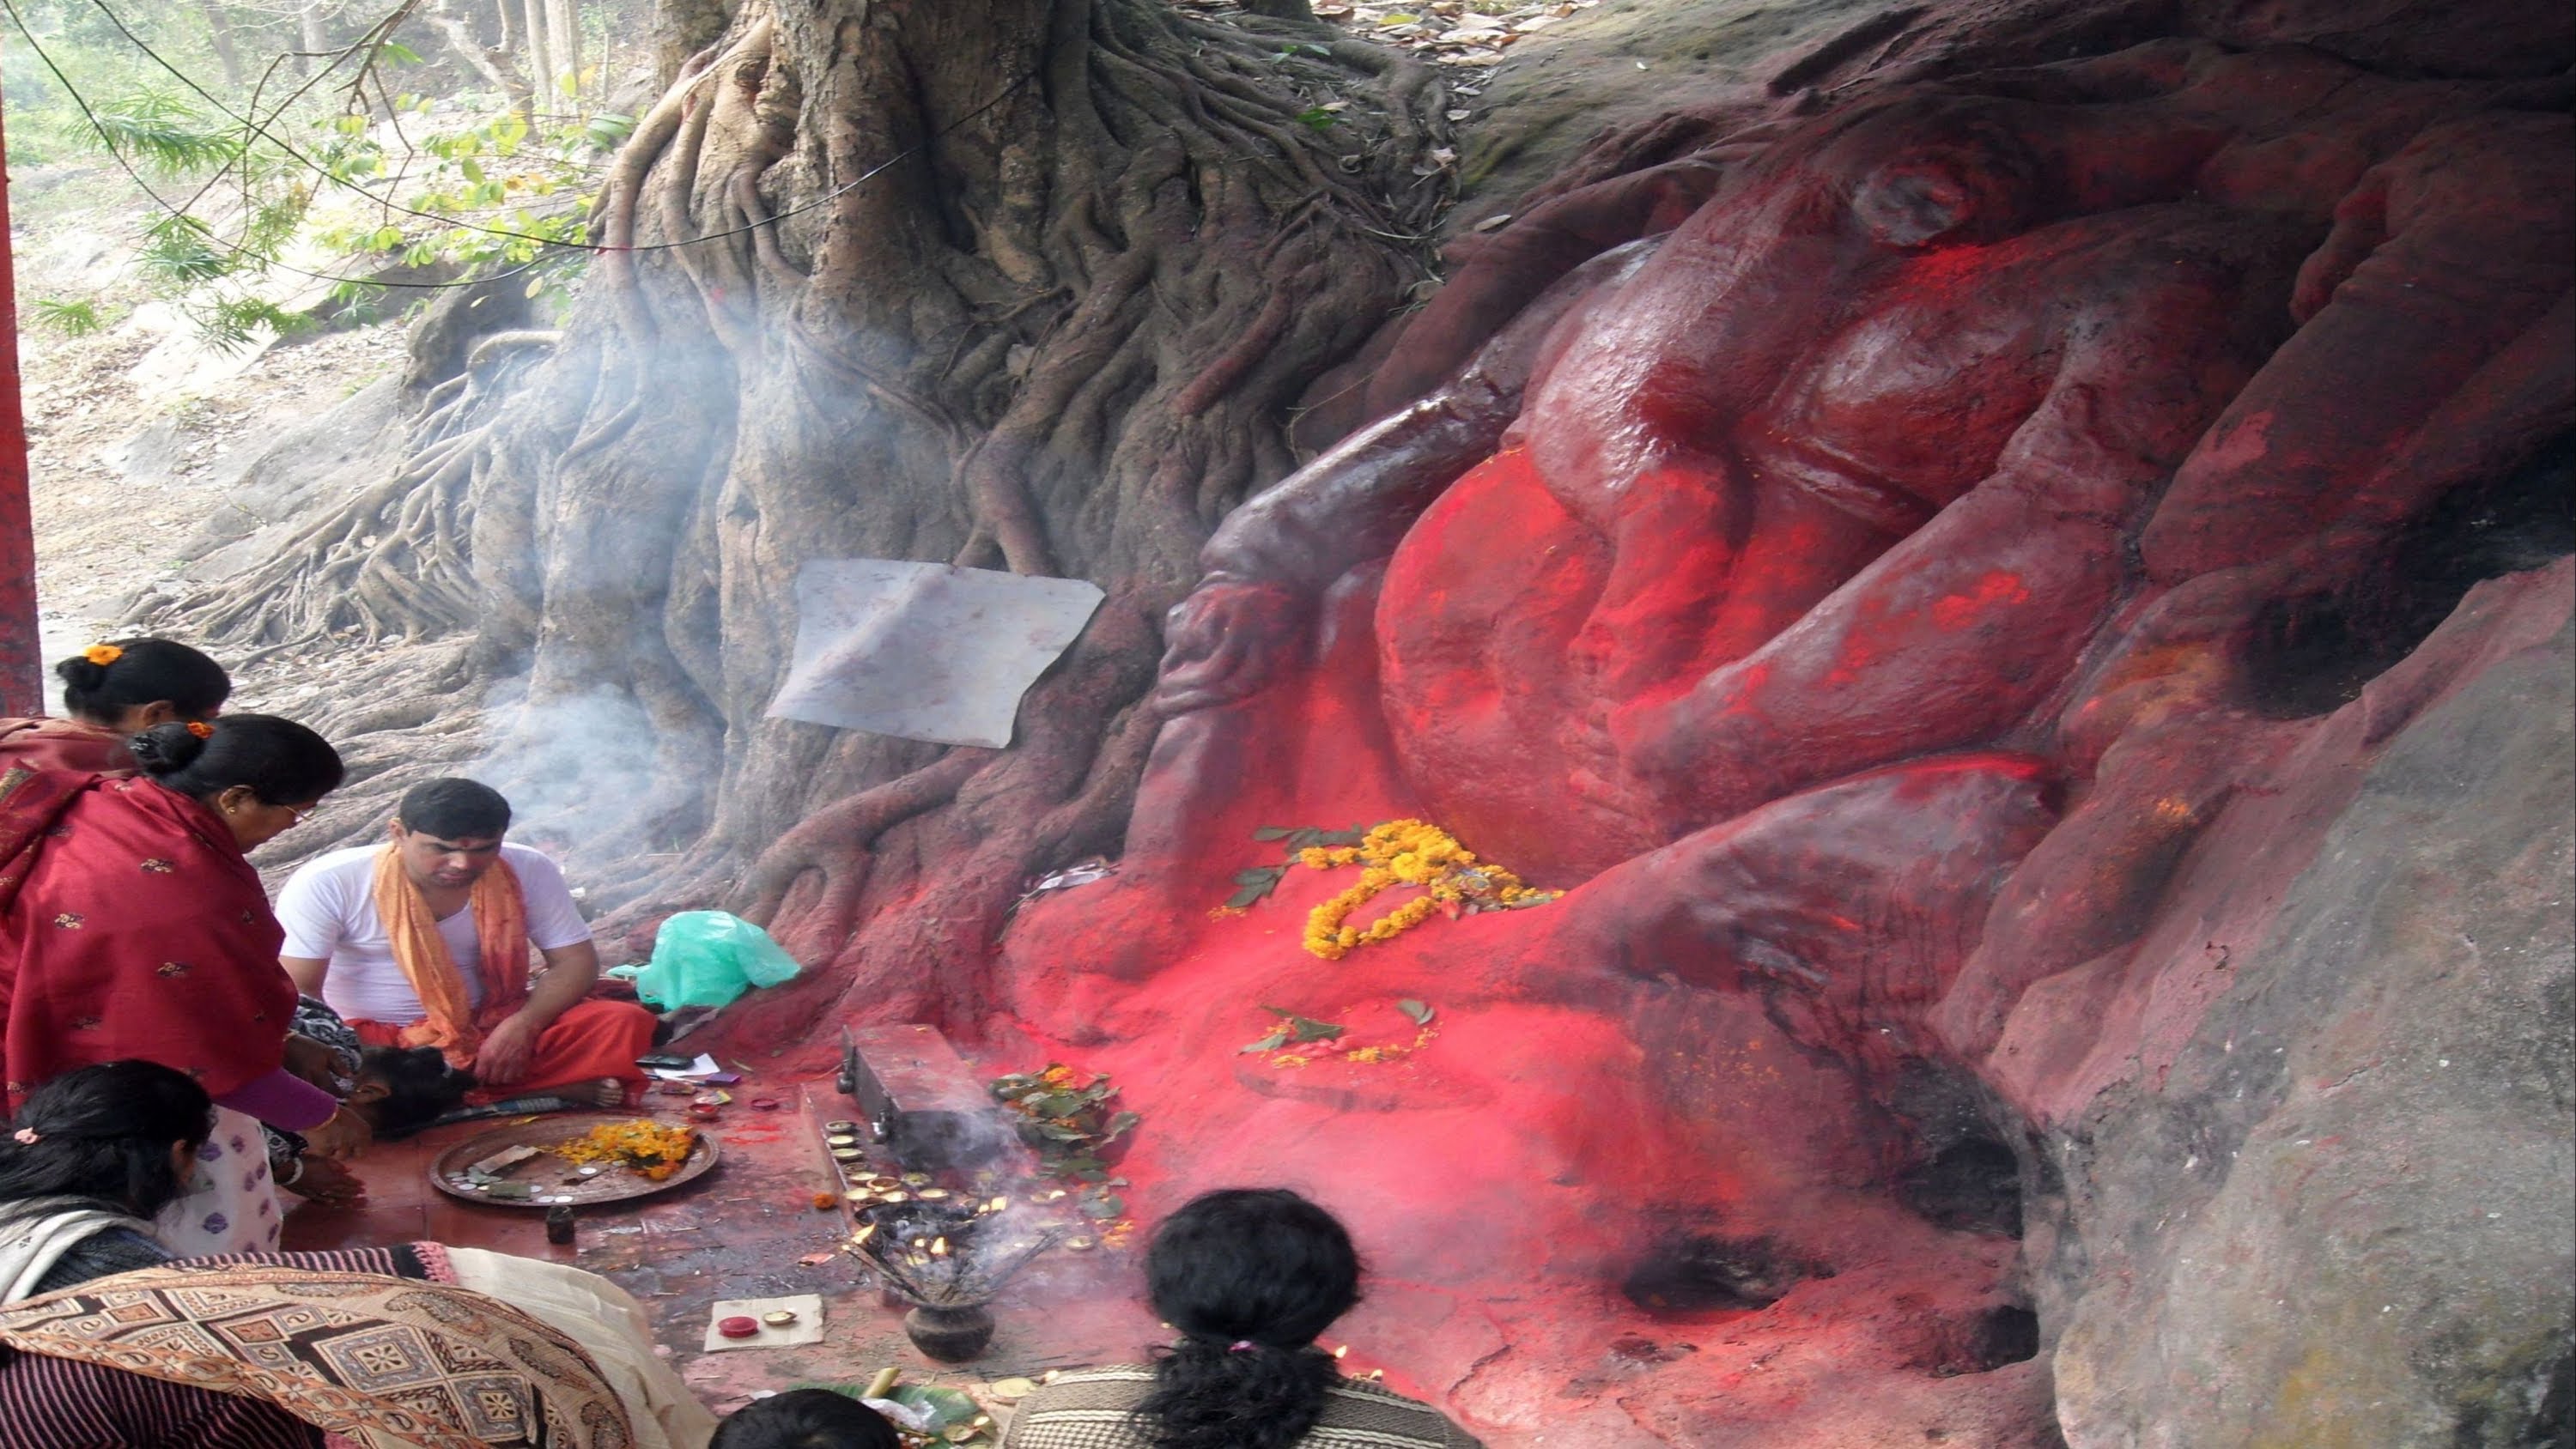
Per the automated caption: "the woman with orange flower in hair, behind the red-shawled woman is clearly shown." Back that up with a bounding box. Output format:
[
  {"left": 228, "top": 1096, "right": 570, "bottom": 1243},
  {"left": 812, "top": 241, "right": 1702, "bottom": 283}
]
[{"left": 0, "top": 639, "right": 232, "bottom": 772}]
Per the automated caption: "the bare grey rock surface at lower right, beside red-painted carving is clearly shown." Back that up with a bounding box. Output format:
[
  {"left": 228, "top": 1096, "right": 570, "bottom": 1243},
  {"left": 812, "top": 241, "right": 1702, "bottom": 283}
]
[{"left": 2030, "top": 567, "right": 2576, "bottom": 1449}]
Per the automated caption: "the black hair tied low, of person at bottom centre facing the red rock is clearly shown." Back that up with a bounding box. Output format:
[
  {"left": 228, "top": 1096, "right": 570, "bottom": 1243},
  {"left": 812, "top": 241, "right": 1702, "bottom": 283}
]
[{"left": 1136, "top": 1189, "right": 1360, "bottom": 1449}]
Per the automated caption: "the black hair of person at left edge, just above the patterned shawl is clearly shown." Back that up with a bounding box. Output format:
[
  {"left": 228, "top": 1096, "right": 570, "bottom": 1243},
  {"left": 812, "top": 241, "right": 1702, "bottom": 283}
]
[{"left": 0, "top": 1060, "right": 214, "bottom": 1217}]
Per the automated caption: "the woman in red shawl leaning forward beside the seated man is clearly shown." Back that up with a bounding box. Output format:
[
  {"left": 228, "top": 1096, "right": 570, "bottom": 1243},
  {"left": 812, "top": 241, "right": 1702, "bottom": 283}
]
[{"left": 0, "top": 716, "right": 366, "bottom": 1253}]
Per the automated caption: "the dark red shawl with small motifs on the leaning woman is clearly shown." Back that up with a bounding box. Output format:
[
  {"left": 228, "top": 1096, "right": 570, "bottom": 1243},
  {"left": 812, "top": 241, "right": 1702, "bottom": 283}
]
[{"left": 0, "top": 769, "right": 296, "bottom": 1104}]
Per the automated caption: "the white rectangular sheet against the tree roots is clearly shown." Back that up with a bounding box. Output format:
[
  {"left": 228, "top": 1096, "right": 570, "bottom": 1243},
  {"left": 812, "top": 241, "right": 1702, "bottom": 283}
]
[{"left": 768, "top": 559, "right": 1105, "bottom": 749}]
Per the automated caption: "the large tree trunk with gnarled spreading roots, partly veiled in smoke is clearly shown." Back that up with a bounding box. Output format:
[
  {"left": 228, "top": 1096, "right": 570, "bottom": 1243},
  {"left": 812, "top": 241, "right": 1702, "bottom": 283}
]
[{"left": 161, "top": 0, "right": 1448, "bottom": 1019}]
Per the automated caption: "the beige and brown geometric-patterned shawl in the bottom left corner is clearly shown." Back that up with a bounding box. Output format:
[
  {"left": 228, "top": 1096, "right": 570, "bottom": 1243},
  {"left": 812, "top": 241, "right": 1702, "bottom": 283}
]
[{"left": 0, "top": 1264, "right": 636, "bottom": 1449}]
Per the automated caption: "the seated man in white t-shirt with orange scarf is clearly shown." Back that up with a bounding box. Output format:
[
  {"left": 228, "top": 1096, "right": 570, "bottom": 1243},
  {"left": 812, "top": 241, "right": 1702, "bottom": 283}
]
[{"left": 278, "top": 777, "right": 654, "bottom": 1104}]
